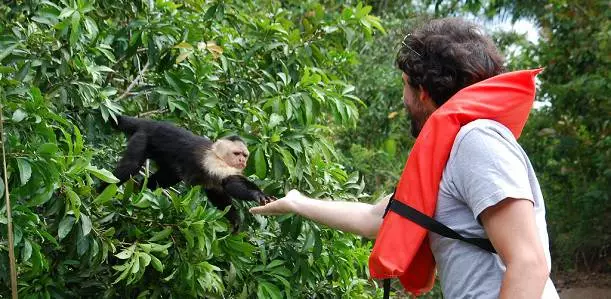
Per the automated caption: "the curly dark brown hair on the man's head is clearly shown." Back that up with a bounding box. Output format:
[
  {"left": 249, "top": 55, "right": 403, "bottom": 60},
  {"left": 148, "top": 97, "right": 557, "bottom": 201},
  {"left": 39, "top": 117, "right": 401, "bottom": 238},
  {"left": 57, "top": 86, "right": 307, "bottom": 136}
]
[{"left": 396, "top": 18, "right": 505, "bottom": 106}]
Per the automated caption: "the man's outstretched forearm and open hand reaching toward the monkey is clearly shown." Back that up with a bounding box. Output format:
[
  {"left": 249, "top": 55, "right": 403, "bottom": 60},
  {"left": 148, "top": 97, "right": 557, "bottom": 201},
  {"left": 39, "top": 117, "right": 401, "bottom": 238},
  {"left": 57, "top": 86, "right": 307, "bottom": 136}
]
[{"left": 250, "top": 190, "right": 391, "bottom": 239}]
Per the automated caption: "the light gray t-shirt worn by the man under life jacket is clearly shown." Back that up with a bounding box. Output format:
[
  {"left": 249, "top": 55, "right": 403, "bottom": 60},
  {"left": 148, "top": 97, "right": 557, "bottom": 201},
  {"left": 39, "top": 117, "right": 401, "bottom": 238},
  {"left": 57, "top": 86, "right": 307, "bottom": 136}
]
[{"left": 429, "top": 120, "right": 558, "bottom": 299}]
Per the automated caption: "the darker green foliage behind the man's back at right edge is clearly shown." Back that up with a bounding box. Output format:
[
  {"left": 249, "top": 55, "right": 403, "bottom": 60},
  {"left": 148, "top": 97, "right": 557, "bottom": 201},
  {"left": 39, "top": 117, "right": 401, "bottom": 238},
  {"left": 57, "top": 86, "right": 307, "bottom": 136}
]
[{"left": 512, "top": 1, "right": 611, "bottom": 271}]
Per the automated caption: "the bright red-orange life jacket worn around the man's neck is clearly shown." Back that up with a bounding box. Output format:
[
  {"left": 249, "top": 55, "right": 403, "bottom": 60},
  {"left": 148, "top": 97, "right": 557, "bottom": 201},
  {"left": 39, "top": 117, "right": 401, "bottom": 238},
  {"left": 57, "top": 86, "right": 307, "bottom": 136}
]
[{"left": 369, "top": 69, "right": 541, "bottom": 296}]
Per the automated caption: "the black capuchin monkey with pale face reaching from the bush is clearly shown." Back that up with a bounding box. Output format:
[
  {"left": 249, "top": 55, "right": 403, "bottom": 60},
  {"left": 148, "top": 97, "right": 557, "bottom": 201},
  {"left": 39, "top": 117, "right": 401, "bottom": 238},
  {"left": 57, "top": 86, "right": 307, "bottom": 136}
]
[{"left": 98, "top": 116, "right": 276, "bottom": 231}]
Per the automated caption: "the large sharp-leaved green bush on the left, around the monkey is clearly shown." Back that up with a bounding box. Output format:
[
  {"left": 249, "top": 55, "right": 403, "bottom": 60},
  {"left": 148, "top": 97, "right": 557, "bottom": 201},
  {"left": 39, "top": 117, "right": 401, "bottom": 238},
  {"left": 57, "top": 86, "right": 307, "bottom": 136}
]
[{"left": 0, "top": 0, "right": 384, "bottom": 298}]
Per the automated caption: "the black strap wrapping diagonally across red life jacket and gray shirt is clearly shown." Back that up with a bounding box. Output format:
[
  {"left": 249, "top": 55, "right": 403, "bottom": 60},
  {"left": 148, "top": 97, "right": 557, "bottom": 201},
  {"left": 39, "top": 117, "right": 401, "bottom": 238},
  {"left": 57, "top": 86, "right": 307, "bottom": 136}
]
[{"left": 387, "top": 197, "right": 496, "bottom": 253}]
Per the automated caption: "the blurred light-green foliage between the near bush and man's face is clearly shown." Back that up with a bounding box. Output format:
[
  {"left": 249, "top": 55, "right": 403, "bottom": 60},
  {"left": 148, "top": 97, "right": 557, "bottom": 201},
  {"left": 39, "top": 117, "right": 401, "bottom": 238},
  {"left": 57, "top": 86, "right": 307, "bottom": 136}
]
[{"left": 337, "top": 8, "right": 418, "bottom": 200}]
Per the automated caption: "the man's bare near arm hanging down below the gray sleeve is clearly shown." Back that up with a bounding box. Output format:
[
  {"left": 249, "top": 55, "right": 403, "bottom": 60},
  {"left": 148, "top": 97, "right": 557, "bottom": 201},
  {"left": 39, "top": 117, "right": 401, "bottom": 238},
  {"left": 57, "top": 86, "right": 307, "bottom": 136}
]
[{"left": 480, "top": 198, "right": 549, "bottom": 299}]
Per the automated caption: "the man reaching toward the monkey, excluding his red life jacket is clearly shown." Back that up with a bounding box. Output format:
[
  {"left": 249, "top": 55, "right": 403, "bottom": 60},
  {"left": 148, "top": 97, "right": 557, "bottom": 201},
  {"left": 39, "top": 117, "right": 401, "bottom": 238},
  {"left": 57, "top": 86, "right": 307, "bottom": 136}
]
[{"left": 251, "top": 18, "right": 558, "bottom": 298}]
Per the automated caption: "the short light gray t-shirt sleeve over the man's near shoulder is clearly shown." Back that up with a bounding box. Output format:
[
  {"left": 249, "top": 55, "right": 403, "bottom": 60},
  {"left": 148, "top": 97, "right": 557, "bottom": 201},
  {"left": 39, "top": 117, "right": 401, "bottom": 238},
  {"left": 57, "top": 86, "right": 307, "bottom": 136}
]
[{"left": 448, "top": 127, "right": 534, "bottom": 219}]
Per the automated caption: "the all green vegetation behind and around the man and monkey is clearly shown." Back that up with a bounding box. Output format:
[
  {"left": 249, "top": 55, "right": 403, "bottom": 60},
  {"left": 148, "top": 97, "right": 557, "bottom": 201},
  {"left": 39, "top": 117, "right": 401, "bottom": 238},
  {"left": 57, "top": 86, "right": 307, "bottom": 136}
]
[{"left": 0, "top": 0, "right": 611, "bottom": 298}]
